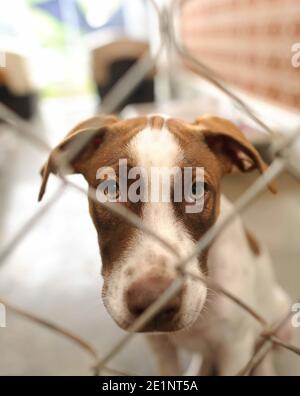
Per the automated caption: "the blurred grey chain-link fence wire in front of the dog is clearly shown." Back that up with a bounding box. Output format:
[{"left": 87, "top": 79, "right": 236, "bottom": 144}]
[{"left": 0, "top": 0, "right": 300, "bottom": 375}]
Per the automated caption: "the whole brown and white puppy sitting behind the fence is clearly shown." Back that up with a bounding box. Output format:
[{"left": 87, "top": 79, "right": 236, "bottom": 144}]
[{"left": 40, "top": 115, "right": 289, "bottom": 375}]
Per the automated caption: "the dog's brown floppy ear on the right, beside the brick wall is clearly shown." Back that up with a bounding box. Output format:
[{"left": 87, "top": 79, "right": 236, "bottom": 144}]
[{"left": 195, "top": 115, "right": 276, "bottom": 193}]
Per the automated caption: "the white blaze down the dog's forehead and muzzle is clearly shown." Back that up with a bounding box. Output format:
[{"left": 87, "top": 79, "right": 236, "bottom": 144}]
[{"left": 107, "top": 120, "right": 206, "bottom": 326}]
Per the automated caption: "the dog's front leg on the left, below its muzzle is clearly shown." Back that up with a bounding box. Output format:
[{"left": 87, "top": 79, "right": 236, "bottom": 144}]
[{"left": 147, "top": 334, "right": 181, "bottom": 375}]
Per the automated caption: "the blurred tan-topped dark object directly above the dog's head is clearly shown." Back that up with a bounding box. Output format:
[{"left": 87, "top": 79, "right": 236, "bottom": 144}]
[{"left": 92, "top": 38, "right": 154, "bottom": 112}]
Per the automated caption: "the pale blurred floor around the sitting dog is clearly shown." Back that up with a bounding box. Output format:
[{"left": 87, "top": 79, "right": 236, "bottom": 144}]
[{"left": 0, "top": 99, "right": 300, "bottom": 375}]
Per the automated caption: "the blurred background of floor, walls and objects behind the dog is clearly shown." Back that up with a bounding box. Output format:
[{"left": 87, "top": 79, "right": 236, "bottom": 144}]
[{"left": 0, "top": 0, "right": 300, "bottom": 375}]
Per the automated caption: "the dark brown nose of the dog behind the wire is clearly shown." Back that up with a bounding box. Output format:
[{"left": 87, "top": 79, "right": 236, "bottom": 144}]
[{"left": 125, "top": 276, "right": 182, "bottom": 321}]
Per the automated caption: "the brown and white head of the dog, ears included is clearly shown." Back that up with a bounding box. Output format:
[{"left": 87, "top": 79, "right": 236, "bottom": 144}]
[{"left": 40, "top": 116, "right": 272, "bottom": 331}]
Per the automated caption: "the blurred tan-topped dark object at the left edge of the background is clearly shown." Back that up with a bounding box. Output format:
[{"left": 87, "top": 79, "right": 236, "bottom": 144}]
[{"left": 0, "top": 52, "right": 37, "bottom": 121}]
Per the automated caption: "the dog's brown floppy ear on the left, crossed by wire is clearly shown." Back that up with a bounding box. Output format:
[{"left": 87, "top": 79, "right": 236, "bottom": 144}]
[{"left": 38, "top": 116, "right": 118, "bottom": 201}]
